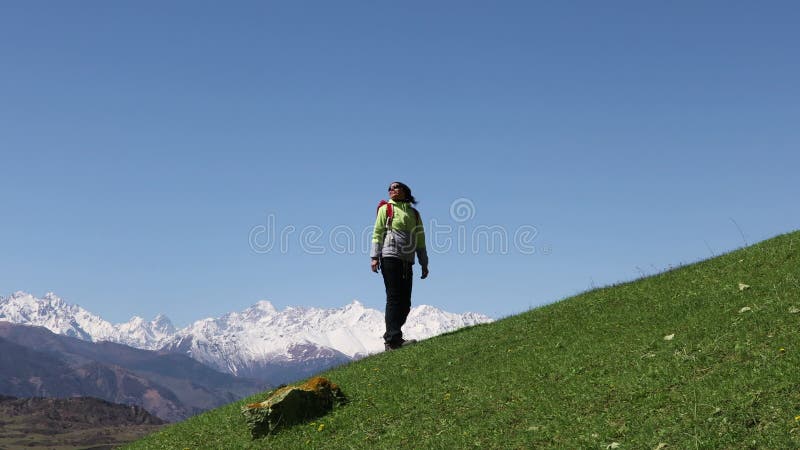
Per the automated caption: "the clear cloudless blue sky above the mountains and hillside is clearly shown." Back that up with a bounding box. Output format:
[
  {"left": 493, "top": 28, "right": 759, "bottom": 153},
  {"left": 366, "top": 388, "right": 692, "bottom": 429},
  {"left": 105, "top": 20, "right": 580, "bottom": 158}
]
[{"left": 0, "top": 1, "right": 800, "bottom": 325}]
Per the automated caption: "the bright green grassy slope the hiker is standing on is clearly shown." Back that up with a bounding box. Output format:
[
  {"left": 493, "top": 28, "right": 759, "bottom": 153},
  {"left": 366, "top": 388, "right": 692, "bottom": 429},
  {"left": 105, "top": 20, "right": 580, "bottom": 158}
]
[{"left": 130, "top": 232, "right": 800, "bottom": 449}]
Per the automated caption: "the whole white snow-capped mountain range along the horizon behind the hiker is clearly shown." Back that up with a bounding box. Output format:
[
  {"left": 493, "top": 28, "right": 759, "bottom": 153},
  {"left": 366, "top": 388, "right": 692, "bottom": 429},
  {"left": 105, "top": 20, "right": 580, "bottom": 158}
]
[{"left": 0, "top": 292, "right": 491, "bottom": 382}]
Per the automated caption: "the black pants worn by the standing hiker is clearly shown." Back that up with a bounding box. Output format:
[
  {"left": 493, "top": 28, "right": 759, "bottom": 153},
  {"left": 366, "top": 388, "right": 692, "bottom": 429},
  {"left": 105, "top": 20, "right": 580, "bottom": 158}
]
[{"left": 381, "top": 258, "right": 413, "bottom": 346}]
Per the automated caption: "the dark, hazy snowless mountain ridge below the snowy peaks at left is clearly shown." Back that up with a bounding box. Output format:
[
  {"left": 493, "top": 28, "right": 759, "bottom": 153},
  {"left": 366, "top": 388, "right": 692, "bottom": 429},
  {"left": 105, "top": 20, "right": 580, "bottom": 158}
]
[{"left": 0, "top": 321, "right": 265, "bottom": 421}]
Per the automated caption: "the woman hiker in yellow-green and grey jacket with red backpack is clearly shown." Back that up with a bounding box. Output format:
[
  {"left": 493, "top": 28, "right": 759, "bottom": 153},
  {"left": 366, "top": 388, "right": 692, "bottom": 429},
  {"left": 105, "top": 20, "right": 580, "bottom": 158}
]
[{"left": 370, "top": 181, "right": 428, "bottom": 350}]
